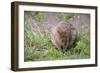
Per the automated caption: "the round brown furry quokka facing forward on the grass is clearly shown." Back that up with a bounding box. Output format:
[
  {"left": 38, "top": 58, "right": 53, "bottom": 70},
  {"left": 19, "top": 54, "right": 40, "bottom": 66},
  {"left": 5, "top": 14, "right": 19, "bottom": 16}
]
[{"left": 51, "top": 21, "right": 77, "bottom": 51}]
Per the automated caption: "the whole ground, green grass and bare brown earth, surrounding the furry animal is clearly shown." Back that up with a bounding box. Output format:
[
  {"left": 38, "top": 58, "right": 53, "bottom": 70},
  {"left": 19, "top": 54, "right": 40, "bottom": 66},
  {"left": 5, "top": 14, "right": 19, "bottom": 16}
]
[{"left": 24, "top": 11, "right": 90, "bottom": 61}]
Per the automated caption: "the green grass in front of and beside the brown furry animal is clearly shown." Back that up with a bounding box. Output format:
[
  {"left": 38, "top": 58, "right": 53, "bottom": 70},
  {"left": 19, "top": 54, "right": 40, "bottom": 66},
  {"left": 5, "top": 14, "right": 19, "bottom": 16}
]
[{"left": 24, "top": 21, "right": 90, "bottom": 61}]
